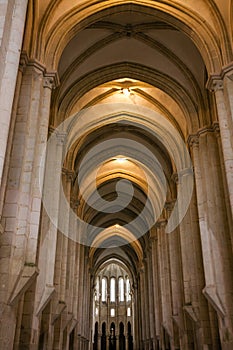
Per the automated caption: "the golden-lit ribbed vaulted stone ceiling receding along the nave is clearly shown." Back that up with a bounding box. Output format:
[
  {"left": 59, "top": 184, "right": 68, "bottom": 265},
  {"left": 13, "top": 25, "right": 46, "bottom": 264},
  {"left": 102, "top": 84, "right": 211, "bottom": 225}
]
[{"left": 24, "top": 0, "right": 232, "bottom": 265}]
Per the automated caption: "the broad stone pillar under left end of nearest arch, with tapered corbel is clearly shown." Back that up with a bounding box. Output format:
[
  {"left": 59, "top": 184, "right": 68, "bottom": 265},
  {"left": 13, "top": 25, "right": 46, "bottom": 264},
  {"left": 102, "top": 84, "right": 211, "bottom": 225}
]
[{"left": 0, "top": 58, "right": 57, "bottom": 348}]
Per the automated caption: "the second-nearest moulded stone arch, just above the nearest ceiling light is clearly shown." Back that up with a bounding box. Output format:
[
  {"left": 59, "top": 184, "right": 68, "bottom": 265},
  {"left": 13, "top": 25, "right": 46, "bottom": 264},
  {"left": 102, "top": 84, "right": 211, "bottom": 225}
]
[{"left": 55, "top": 62, "right": 202, "bottom": 133}]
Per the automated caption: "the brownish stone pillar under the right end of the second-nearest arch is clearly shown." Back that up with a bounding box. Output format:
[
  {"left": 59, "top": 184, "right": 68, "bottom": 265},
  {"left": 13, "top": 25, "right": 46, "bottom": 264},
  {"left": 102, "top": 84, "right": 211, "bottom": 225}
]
[{"left": 189, "top": 130, "right": 233, "bottom": 349}]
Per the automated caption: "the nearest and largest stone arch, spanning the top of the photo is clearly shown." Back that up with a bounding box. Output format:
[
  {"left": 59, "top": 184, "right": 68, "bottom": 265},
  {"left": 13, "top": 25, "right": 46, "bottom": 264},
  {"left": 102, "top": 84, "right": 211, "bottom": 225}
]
[{"left": 38, "top": 0, "right": 230, "bottom": 73}]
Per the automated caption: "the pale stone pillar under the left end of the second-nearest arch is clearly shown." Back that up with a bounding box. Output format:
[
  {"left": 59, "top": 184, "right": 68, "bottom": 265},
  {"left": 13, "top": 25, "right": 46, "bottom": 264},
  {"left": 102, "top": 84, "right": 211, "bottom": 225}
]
[{"left": 30, "top": 129, "right": 65, "bottom": 350}]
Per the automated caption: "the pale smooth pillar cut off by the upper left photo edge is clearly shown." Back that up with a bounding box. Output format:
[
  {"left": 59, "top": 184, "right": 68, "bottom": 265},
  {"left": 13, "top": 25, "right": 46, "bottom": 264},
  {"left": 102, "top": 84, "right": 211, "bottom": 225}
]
[{"left": 0, "top": 0, "right": 28, "bottom": 185}]
